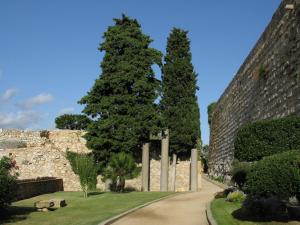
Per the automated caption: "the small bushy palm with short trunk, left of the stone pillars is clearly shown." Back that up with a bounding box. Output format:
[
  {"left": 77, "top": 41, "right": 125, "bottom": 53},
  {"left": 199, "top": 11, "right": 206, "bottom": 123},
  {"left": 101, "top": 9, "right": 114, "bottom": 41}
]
[{"left": 104, "top": 152, "right": 140, "bottom": 192}]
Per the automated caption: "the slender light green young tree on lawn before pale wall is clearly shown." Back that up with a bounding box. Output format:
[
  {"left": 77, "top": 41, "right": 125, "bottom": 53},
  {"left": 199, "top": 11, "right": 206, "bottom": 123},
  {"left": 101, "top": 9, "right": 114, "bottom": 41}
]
[{"left": 73, "top": 154, "right": 97, "bottom": 198}]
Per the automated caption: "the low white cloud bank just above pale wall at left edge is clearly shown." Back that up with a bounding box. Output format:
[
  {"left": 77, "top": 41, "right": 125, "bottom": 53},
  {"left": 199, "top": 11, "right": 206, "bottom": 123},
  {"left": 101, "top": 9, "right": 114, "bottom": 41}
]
[{"left": 0, "top": 111, "right": 42, "bottom": 129}]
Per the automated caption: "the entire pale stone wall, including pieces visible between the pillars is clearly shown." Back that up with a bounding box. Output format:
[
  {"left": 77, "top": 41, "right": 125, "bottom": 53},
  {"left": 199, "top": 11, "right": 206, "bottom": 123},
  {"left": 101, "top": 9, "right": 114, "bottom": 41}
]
[{"left": 0, "top": 129, "right": 197, "bottom": 191}]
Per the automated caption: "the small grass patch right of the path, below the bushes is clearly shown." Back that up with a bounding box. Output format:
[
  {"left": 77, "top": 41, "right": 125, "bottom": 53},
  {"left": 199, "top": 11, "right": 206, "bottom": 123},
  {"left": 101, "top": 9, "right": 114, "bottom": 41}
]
[{"left": 211, "top": 198, "right": 300, "bottom": 225}]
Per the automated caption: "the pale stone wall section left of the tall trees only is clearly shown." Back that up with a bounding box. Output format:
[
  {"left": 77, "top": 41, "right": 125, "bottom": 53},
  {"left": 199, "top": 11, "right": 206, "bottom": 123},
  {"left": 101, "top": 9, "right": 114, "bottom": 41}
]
[{"left": 0, "top": 130, "right": 90, "bottom": 191}]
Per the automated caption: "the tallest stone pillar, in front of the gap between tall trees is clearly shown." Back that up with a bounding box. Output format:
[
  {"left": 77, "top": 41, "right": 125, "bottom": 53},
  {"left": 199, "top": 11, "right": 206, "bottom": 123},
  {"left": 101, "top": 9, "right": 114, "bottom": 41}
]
[{"left": 160, "top": 130, "right": 169, "bottom": 191}]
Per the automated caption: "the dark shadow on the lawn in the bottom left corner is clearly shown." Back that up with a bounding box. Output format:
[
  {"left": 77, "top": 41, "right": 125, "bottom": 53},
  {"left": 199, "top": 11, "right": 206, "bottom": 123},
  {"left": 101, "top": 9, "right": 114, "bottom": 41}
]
[{"left": 0, "top": 206, "right": 36, "bottom": 224}]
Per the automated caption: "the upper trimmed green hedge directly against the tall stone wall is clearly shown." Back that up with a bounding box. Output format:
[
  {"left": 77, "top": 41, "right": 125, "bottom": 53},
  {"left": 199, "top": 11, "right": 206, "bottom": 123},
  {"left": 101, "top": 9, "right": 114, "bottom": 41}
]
[{"left": 234, "top": 117, "right": 300, "bottom": 162}]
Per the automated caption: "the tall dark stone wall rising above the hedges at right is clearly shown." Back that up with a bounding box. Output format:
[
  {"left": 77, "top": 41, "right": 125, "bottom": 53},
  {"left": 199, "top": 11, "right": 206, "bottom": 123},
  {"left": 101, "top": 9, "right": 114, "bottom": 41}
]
[{"left": 209, "top": 0, "right": 300, "bottom": 176}]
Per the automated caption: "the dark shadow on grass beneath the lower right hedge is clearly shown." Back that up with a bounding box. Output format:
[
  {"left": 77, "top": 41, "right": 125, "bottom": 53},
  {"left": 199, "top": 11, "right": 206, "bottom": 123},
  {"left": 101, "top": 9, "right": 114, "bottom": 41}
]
[{"left": 231, "top": 207, "right": 300, "bottom": 223}]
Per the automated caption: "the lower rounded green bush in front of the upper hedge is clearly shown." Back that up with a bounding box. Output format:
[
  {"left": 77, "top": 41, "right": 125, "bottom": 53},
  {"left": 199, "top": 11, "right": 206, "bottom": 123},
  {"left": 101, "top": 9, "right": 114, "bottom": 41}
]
[{"left": 246, "top": 150, "right": 300, "bottom": 200}]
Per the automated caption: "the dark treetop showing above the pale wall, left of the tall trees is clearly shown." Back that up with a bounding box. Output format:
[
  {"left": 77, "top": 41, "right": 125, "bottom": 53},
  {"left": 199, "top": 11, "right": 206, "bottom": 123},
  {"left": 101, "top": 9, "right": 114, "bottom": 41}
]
[{"left": 55, "top": 114, "right": 91, "bottom": 130}]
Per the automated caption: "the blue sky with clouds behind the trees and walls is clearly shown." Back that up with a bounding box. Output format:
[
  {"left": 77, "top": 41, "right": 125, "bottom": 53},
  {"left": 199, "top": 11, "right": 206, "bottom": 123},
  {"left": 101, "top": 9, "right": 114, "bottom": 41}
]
[{"left": 0, "top": 0, "right": 280, "bottom": 144}]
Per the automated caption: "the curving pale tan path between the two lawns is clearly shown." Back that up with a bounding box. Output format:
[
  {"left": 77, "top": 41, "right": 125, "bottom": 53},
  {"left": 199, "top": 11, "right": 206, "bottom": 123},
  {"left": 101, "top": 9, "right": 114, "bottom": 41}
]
[{"left": 113, "top": 179, "right": 221, "bottom": 225}]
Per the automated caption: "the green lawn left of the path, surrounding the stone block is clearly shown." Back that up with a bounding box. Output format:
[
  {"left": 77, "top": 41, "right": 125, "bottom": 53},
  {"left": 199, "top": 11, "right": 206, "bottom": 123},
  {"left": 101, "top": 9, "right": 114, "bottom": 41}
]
[{"left": 0, "top": 192, "right": 171, "bottom": 225}]
